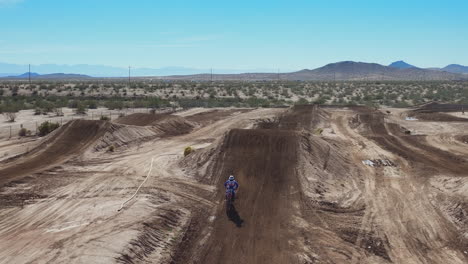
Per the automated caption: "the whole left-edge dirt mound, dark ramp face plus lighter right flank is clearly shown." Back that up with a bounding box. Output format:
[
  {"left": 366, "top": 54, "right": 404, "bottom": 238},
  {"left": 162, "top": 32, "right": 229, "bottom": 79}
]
[{"left": 0, "top": 120, "right": 167, "bottom": 185}]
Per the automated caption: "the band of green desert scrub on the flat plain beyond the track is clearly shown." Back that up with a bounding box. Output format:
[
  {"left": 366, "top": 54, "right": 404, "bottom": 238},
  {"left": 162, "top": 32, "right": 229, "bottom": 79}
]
[{"left": 0, "top": 80, "right": 468, "bottom": 110}]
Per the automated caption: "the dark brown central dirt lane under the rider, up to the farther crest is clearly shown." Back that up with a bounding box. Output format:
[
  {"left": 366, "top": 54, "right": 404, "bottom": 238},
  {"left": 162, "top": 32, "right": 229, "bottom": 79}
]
[{"left": 173, "top": 106, "right": 363, "bottom": 264}]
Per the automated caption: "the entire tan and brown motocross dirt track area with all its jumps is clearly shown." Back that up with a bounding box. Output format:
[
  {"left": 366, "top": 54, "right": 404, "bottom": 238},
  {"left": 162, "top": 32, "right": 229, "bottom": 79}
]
[{"left": 0, "top": 106, "right": 468, "bottom": 263}]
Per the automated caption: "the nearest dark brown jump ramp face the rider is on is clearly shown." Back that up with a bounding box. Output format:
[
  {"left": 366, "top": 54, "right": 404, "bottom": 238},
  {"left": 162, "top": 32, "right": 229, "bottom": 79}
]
[{"left": 200, "top": 129, "right": 299, "bottom": 263}]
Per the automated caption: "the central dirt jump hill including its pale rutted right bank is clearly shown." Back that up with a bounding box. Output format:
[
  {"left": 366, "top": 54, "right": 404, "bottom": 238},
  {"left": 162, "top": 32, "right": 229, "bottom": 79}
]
[{"left": 173, "top": 106, "right": 378, "bottom": 263}]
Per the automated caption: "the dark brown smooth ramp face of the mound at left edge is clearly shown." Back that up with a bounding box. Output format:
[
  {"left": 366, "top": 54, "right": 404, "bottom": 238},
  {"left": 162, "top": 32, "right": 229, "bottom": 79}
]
[{"left": 0, "top": 120, "right": 110, "bottom": 185}]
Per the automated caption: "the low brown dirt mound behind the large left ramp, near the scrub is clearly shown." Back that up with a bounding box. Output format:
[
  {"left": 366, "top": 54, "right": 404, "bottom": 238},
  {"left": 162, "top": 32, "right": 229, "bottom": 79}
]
[{"left": 114, "top": 113, "right": 194, "bottom": 136}]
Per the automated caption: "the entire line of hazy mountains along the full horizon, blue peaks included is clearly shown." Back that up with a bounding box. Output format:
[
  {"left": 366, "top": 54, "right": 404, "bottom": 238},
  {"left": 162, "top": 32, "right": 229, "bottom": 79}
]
[{"left": 0, "top": 61, "right": 468, "bottom": 81}]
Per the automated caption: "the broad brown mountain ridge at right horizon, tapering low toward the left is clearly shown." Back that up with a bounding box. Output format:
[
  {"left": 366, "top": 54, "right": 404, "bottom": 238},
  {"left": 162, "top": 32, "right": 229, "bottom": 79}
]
[{"left": 167, "top": 61, "right": 468, "bottom": 81}]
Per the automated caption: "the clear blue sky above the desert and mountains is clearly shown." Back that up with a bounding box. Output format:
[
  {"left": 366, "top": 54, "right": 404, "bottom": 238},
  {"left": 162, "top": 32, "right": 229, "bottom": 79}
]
[{"left": 0, "top": 0, "right": 468, "bottom": 71}]
